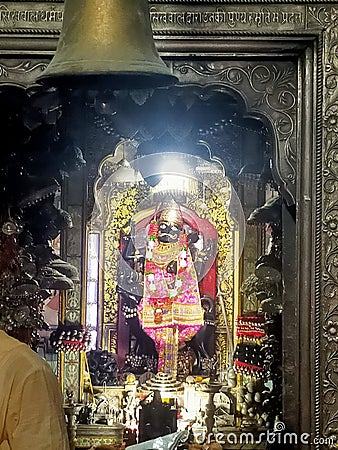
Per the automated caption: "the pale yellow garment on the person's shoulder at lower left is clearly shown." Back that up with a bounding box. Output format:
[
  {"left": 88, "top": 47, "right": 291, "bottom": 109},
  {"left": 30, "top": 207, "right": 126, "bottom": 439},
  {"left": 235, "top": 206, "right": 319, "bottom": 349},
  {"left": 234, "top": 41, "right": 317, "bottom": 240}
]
[{"left": 0, "top": 330, "right": 69, "bottom": 450}]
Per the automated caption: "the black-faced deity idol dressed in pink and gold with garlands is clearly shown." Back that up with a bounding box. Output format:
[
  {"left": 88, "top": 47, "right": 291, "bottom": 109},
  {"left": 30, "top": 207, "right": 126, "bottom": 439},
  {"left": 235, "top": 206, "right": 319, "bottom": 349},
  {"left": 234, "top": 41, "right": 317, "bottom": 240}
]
[{"left": 138, "top": 202, "right": 204, "bottom": 374}]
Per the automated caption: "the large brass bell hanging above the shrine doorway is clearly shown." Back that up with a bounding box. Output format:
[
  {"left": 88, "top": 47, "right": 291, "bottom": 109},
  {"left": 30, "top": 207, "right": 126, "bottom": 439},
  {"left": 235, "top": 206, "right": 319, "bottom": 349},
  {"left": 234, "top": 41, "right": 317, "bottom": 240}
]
[{"left": 37, "top": 0, "right": 177, "bottom": 89}]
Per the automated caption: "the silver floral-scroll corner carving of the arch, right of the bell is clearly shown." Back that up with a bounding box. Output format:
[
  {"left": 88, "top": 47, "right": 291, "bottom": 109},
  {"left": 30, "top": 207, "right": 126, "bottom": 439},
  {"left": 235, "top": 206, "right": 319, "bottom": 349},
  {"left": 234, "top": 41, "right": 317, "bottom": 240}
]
[{"left": 173, "top": 61, "right": 297, "bottom": 203}]
